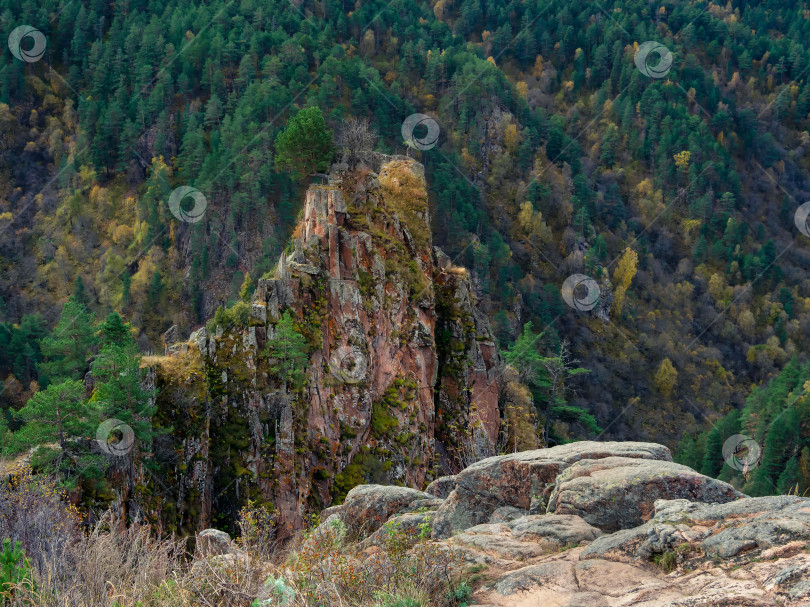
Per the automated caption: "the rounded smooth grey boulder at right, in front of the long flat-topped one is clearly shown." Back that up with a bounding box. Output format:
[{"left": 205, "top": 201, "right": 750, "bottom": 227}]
[{"left": 548, "top": 457, "right": 744, "bottom": 531}]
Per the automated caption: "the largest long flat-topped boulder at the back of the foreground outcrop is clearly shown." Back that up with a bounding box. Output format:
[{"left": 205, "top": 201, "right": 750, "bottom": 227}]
[{"left": 428, "top": 441, "right": 672, "bottom": 539}]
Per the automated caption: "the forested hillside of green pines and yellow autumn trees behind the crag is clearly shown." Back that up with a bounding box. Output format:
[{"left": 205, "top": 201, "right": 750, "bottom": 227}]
[{"left": 0, "top": 0, "right": 810, "bottom": 452}]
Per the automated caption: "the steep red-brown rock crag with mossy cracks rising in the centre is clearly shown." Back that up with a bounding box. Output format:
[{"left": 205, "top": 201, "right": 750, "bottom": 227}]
[{"left": 146, "top": 159, "right": 499, "bottom": 536}]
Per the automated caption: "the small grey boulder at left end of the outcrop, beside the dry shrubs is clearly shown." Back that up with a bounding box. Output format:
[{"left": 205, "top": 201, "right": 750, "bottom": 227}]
[{"left": 321, "top": 485, "right": 435, "bottom": 538}]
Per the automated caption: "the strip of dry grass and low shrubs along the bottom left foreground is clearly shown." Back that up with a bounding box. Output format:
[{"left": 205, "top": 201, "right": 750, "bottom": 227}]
[{"left": 0, "top": 474, "right": 468, "bottom": 607}]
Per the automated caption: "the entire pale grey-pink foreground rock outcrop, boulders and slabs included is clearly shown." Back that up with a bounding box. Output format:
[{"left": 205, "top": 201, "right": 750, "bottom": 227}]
[{"left": 310, "top": 441, "right": 810, "bottom": 607}]
